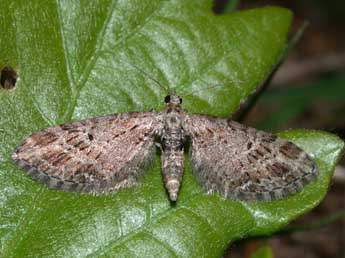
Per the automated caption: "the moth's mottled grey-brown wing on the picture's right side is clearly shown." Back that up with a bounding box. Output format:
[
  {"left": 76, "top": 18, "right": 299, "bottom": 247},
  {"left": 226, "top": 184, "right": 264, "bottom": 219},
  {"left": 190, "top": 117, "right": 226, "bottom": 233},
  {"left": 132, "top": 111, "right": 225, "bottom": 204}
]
[{"left": 186, "top": 115, "right": 318, "bottom": 201}]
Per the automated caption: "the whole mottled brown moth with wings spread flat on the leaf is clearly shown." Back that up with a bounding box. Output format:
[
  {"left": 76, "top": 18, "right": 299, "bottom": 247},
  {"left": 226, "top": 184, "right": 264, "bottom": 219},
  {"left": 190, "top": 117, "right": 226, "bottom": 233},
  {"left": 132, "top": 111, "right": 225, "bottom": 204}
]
[{"left": 12, "top": 91, "right": 318, "bottom": 202}]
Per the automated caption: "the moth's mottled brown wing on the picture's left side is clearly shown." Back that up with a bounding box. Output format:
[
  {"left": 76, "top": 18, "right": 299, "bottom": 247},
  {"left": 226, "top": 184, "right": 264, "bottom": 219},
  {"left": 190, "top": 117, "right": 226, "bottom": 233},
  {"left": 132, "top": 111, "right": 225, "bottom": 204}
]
[{"left": 12, "top": 112, "right": 160, "bottom": 193}]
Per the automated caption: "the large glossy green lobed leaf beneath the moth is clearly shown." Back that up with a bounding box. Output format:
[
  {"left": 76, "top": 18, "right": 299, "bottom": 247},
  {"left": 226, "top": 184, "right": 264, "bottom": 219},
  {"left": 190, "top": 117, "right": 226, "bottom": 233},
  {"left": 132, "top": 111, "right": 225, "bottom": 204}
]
[{"left": 0, "top": 0, "right": 343, "bottom": 257}]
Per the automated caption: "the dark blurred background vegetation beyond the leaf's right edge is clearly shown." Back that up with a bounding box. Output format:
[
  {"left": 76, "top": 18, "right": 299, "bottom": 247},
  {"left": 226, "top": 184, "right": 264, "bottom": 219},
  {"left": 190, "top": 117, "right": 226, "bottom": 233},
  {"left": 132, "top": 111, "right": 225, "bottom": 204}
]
[{"left": 214, "top": 0, "right": 345, "bottom": 258}]
